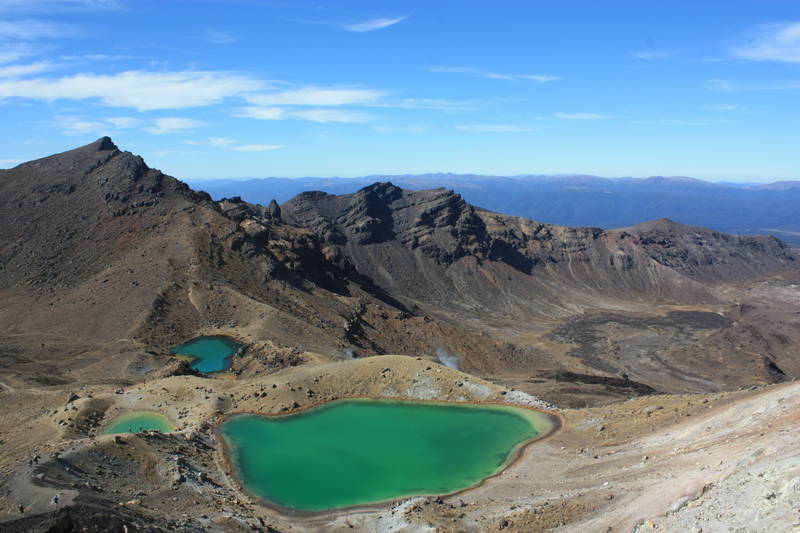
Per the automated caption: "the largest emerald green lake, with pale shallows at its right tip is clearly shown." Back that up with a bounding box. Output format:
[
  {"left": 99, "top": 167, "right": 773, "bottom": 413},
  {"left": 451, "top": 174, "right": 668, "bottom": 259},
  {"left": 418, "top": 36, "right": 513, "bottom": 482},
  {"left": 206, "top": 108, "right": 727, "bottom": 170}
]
[{"left": 221, "top": 400, "right": 553, "bottom": 511}]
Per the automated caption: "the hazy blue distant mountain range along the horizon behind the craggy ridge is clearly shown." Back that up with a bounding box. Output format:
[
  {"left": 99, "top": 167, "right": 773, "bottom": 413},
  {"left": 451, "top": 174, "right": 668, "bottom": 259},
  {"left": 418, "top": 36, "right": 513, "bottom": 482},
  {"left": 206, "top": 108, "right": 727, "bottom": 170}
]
[{"left": 190, "top": 174, "right": 800, "bottom": 245}]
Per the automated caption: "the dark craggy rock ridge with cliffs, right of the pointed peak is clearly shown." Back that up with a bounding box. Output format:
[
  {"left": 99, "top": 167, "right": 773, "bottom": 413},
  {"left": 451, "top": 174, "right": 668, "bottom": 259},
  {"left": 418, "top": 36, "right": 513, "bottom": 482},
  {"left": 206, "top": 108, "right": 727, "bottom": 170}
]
[{"left": 282, "top": 183, "right": 795, "bottom": 316}]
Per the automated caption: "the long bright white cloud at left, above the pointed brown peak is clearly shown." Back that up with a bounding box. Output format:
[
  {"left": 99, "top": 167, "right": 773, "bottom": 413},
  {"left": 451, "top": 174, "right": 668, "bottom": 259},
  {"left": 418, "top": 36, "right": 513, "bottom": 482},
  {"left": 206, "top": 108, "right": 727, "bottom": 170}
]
[{"left": 0, "top": 71, "right": 264, "bottom": 111}]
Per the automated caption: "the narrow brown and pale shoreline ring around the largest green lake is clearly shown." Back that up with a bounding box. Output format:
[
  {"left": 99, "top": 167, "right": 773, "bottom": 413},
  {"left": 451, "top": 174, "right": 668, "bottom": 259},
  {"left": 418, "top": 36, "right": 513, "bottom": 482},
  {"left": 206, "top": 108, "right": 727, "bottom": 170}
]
[{"left": 213, "top": 396, "right": 564, "bottom": 517}]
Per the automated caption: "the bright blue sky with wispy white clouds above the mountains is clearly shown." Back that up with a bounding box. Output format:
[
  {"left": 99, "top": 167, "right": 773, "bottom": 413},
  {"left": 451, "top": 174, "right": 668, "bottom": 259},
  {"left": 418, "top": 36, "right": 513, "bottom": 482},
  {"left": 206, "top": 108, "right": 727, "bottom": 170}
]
[{"left": 0, "top": 0, "right": 800, "bottom": 181}]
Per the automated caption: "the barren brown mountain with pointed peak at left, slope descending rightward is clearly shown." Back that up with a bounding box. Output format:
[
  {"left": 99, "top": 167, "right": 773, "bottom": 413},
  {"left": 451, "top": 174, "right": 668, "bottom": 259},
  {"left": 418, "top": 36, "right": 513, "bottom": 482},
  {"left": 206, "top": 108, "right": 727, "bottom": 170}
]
[{"left": 0, "top": 138, "right": 536, "bottom": 384}]
